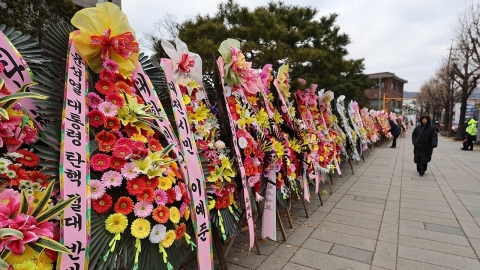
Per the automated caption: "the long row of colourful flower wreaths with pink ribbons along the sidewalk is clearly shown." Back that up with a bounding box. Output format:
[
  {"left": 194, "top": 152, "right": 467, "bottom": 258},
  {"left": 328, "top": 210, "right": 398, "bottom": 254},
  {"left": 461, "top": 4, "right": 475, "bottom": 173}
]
[{"left": 0, "top": 3, "right": 402, "bottom": 270}]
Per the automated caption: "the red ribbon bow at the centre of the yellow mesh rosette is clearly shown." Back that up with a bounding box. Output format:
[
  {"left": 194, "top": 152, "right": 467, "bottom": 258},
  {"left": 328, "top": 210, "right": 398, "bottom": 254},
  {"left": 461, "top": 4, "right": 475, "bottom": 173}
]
[{"left": 90, "top": 28, "right": 139, "bottom": 59}]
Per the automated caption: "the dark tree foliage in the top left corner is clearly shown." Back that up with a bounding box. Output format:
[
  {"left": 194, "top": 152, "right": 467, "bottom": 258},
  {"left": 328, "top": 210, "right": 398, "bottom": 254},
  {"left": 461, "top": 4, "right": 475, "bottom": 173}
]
[{"left": 0, "top": 0, "right": 77, "bottom": 42}]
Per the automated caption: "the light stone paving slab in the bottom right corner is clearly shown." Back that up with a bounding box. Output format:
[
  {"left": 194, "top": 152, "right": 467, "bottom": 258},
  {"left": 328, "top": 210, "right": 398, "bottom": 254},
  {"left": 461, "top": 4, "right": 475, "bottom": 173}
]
[{"left": 398, "top": 245, "right": 480, "bottom": 270}]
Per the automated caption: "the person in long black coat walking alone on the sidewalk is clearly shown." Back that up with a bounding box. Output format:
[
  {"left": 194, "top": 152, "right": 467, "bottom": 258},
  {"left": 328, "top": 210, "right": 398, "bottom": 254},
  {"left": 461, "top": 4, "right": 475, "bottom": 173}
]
[{"left": 412, "top": 115, "right": 438, "bottom": 175}]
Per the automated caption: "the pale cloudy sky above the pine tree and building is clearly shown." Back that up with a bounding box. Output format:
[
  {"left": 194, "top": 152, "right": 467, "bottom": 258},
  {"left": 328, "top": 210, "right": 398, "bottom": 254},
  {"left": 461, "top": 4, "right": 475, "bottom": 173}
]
[{"left": 122, "top": 0, "right": 471, "bottom": 92}]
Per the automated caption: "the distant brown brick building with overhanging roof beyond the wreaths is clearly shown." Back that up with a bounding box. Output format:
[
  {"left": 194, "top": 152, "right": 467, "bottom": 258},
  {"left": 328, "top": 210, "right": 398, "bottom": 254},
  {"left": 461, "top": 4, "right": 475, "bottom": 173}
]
[{"left": 365, "top": 72, "right": 408, "bottom": 113}]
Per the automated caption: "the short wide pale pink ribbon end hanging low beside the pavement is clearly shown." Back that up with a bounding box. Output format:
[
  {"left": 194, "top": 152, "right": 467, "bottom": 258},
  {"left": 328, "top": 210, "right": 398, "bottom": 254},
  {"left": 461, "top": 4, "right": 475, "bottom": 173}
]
[{"left": 262, "top": 168, "right": 277, "bottom": 241}]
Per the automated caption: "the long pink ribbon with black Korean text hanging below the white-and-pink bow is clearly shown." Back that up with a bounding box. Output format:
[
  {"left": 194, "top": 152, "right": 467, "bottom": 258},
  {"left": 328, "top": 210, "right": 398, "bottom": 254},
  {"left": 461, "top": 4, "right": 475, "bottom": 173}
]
[{"left": 160, "top": 58, "right": 213, "bottom": 270}]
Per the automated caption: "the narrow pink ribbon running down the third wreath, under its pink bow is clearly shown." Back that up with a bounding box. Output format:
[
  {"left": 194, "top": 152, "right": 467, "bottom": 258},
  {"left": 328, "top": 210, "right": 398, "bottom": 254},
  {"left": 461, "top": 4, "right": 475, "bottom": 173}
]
[{"left": 217, "top": 57, "right": 255, "bottom": 249}]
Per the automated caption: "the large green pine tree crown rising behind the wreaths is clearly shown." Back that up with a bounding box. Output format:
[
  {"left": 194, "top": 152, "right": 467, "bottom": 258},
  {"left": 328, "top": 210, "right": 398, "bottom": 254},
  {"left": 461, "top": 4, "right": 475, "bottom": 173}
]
[{"left": 152, "top": 0, "right": 371, "bottom": 105}]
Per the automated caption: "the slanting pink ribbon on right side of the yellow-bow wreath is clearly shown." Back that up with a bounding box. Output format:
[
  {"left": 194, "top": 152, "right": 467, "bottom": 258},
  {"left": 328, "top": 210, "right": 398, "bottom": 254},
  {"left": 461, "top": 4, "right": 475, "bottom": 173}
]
[{"left": 133, "top": 62, "right": 188, "bottom": 181}]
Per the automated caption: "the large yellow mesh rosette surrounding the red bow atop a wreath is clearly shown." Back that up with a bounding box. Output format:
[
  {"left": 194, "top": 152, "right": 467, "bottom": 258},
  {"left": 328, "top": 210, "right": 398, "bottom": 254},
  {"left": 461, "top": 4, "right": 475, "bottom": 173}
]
[{"left": 71, "top": 3, "right": 139, "bottom": 77}]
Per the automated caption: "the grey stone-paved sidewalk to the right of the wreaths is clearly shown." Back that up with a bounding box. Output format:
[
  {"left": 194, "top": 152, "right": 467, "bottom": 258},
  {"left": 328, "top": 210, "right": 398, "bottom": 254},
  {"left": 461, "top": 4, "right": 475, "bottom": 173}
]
[{"left": 227, "top": 130, "right": 480, "bottom": 270}]
